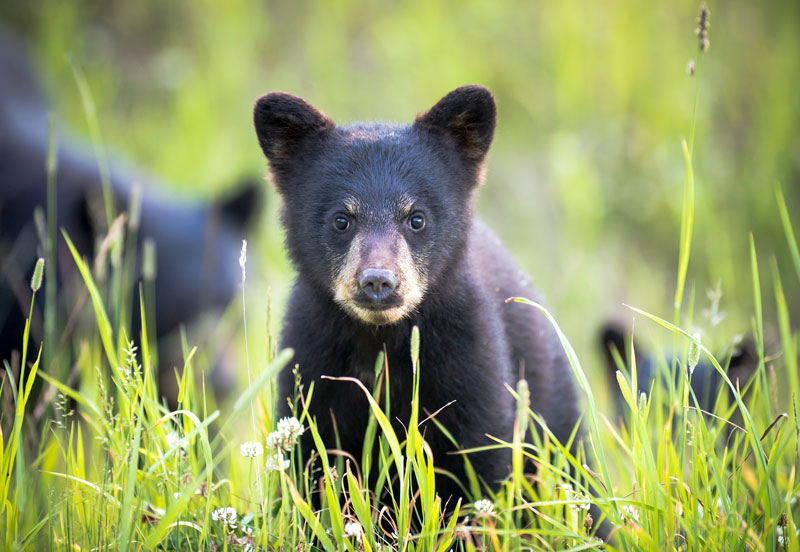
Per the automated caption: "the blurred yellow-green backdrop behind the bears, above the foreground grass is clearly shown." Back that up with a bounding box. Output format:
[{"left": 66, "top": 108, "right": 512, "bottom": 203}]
[{"left": 0, "top": 0, "right": 800, "bottom": 410}]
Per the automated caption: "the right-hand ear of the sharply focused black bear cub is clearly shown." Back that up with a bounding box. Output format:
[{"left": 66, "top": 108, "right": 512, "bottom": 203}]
[{"left": 414, "top": 84, "right": 497, "bottom": 165}]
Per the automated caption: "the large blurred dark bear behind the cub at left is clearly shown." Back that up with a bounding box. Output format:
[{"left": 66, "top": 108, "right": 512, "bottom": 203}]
[{"left": 0, "top": 29, "right": 260, "bottom": 395}]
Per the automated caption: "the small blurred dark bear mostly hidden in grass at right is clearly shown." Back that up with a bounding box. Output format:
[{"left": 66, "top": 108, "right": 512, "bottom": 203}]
[{"left": 599, "top": 323, "right": 758, "bottom": 423}]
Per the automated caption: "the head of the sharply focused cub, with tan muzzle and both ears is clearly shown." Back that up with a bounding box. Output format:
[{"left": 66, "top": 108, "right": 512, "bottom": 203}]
[{"left": 254, "top": 86, "right": 496, "bottom": 325}]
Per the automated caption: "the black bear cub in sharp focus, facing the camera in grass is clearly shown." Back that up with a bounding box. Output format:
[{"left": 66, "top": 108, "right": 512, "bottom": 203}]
[{"left": 254, "top": 86, "right": 578, "bottom": 500}]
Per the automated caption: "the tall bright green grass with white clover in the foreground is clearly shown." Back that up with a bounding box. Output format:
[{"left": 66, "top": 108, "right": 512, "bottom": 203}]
[{"left": 0, "top": 141, "right": 800, "bottom": 551}]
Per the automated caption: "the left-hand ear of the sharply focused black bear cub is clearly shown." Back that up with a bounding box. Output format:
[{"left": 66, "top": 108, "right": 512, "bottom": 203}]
[{"left": 253, "top": 92, "right": 335, "bottom": 168}]
